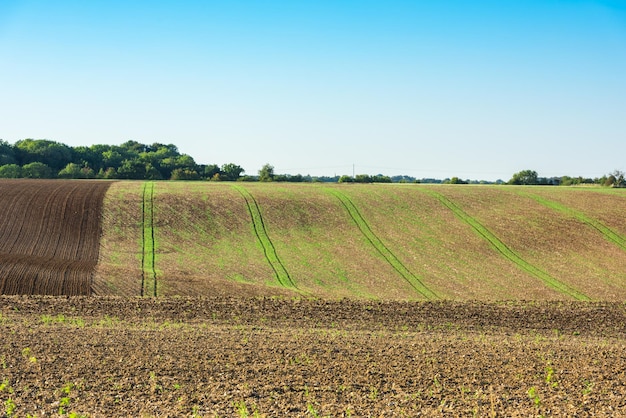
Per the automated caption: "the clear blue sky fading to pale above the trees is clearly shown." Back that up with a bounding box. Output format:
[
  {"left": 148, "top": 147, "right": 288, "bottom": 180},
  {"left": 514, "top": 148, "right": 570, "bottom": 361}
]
[{"left": 0, "top": 0, "right": 626, "bottom": 181}]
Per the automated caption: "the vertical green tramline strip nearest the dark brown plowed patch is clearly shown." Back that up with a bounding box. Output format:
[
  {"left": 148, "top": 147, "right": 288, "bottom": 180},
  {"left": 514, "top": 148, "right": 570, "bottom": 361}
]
[{"left": 141, "top": 181, "right": 157, "bottom": 296}]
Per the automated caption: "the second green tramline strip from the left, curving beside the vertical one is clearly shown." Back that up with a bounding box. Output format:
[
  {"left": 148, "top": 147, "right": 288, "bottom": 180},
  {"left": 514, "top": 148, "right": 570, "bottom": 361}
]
[{"left": 232, "top": 186, "right": 297, "bottom": 289}]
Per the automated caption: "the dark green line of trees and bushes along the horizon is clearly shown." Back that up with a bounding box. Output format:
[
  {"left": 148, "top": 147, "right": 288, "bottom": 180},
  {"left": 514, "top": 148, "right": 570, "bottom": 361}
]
[{"left": 0, "top": 139, "right": 626, "bottom": 187}]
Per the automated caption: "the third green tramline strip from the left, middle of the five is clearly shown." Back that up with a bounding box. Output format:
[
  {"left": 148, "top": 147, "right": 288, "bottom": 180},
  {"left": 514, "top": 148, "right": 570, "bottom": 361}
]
[{"left": 327, "top": 189, "right": 439, "bottom": 300}]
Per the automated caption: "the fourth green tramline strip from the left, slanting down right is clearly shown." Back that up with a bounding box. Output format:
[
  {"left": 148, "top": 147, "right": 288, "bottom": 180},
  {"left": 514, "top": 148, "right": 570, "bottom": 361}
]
[{"left": 425, "top": 190, "right": 590, "bottom": 300}]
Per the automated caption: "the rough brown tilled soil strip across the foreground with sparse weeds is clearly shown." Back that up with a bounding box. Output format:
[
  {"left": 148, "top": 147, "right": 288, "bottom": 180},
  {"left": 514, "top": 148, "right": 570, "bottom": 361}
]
[{"left": 0, "top": 296, "right": 626, "bottom": 417}]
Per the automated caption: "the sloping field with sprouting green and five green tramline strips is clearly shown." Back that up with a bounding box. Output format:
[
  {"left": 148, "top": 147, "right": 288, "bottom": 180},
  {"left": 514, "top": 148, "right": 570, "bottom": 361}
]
[{"left": 94, "top": 182, "right": 626, "bottom": 300}]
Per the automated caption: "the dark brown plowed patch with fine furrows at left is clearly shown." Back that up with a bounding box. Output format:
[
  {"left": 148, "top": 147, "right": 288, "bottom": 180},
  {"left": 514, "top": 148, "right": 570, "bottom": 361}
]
[{"left": 0, "top": 180, "right": 110, "bottom": 295}]
